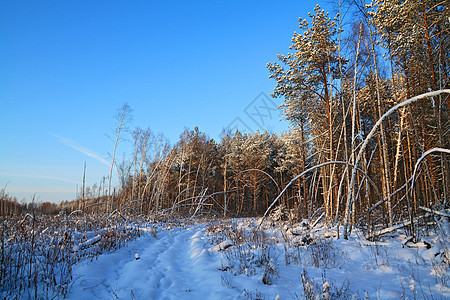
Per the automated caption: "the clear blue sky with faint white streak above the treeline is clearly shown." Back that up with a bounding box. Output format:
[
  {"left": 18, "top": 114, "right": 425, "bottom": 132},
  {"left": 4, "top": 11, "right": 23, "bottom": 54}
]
[{"left": 0, "top": 0, "right": 327, "bottom": 202}]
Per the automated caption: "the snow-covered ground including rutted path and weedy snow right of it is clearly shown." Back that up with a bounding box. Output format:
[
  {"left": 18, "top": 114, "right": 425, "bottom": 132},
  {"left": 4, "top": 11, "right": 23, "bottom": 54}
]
[{"left": 68, "top": 219, "right": 450, "bottom": 299}]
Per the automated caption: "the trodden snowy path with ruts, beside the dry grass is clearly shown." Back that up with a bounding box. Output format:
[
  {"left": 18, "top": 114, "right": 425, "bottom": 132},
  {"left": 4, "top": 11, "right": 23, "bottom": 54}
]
[{"left": 68, "top": 225, "right": 239, "bottom": 299}]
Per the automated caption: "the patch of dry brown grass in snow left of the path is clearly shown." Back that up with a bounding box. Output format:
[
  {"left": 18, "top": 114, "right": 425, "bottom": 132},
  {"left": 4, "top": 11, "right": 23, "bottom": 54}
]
[{"left": 0, "top": 213, "right": 141, "bottom": 299}]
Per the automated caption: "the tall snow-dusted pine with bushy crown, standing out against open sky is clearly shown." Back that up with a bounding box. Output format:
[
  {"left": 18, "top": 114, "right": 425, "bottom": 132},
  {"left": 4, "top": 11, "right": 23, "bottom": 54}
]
[{"left": 267, "top": 5, "right": 340, "bottom": 218}]
